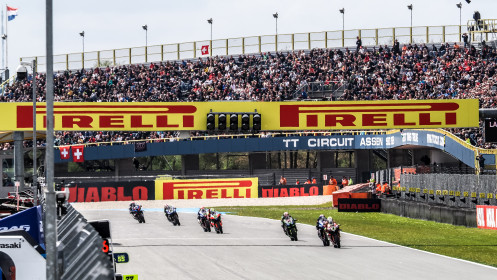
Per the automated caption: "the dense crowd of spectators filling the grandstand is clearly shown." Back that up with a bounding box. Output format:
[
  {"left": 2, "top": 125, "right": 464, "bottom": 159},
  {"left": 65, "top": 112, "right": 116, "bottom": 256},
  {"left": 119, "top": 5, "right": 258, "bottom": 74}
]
[{"left": 0, "top": 42, "right": 497, "bottom": 149}]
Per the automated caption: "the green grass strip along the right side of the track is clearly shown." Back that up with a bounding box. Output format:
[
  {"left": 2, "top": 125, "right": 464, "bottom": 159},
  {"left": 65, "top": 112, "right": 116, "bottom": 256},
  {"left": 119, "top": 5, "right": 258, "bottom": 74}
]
[{"left": 216, "top": 203, "right": 497, "bottom": 267}]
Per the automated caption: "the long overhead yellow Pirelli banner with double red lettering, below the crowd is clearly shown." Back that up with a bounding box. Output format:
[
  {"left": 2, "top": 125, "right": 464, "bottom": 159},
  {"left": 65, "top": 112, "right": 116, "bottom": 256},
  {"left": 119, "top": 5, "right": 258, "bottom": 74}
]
[{"left": 4, "top": 99, "right": 479, "bottom": 131}]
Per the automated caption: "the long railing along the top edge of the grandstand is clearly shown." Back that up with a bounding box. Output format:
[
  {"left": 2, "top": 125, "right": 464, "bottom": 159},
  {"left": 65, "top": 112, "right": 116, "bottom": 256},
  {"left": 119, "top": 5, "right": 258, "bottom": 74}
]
[{"left": 21, "top": 25, "right": 465, "bottom": 72}]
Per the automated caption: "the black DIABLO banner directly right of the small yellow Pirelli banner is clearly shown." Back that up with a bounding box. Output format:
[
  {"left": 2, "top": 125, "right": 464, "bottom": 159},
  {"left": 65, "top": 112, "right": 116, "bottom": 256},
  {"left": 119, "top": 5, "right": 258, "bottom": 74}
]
[{"left": 259, "top": 184, "right": 323, "bottom": 197}]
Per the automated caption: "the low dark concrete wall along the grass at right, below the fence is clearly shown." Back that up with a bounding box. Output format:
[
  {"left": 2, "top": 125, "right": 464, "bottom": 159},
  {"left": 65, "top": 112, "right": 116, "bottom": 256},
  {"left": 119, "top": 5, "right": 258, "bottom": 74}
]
[{"left": 381, "top": 199, "right": 476, "bottom": 227}]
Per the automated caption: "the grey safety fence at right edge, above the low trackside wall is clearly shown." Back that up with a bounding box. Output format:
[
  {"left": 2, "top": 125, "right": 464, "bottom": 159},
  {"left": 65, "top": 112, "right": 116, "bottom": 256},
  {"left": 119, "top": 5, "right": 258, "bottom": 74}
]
[{"left": 392, "top": 174, "right": 497, "bottom": 208}]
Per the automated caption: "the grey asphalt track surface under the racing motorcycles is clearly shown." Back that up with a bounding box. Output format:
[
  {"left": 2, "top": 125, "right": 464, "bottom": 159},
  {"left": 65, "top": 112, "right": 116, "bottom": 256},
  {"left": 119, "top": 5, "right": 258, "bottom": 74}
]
[{"left": 81, "top": 209, "right": 497, "bottom": 280}]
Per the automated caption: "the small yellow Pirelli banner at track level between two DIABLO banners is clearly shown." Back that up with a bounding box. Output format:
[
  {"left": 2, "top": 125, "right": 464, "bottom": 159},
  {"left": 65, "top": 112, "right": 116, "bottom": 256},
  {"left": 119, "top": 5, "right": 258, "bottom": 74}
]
[{"left": 155, "top": 178, "right": 259, "bottom": 200}]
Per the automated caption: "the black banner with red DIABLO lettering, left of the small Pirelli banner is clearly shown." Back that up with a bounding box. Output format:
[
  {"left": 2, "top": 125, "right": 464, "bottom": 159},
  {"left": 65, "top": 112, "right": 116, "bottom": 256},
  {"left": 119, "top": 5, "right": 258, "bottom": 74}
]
[{"left": 69, "top": 181, "right": 155, "bottom": 202}]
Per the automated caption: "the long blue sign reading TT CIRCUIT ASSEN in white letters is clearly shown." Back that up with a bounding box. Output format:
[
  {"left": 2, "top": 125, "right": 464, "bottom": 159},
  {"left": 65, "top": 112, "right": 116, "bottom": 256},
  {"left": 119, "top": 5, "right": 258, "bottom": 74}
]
[{"left": 55, "top": 129, "right": 486, "bottom": 167}]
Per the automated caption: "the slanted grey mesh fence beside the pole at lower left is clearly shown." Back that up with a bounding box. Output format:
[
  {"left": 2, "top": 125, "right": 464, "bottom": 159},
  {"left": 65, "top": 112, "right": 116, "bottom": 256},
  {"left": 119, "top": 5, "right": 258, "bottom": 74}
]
[{"left": 57, "top": 204, "right": 114, "bottom": 280}]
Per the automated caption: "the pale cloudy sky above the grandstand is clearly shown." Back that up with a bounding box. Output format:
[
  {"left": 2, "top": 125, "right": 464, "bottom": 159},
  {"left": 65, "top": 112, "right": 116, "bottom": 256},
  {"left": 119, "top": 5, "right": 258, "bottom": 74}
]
[{"left": 0, "top": 0, "right": 497, "bottom": 71}]
